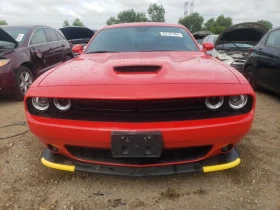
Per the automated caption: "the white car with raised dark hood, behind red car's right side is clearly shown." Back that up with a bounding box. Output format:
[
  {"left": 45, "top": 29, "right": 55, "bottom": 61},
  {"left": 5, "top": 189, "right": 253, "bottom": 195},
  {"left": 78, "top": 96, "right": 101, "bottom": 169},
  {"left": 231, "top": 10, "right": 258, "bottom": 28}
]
[{"left": 214, "top": 22, "right": 267, "bottom": 72}]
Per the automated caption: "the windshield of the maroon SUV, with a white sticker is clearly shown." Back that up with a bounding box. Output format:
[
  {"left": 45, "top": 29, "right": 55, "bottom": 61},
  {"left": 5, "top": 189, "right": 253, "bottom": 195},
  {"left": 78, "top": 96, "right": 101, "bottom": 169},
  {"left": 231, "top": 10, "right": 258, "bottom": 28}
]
[{"left": 0, "top": 27, "right": 29, "bottom": 48}]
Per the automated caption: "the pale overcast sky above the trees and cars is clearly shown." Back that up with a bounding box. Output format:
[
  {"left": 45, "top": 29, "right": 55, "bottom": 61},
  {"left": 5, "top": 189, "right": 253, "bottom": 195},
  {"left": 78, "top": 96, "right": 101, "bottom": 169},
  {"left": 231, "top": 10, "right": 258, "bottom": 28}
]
[{"left": 0, "top": 0, "right": 280, "bottom": 29}]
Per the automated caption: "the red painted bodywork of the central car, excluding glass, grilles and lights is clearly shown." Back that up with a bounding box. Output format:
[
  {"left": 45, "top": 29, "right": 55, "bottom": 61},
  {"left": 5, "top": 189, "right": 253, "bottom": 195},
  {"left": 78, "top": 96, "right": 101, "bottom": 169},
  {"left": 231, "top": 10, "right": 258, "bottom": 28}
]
[{"left": 25, "top": 23, "right": 255, "bottom": 167}]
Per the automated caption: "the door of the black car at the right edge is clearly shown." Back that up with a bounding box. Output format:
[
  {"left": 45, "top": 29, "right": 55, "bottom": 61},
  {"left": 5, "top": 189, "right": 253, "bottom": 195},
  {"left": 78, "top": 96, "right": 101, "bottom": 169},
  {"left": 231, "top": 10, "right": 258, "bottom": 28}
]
[{"left": 256, "top": 30, "right": 280, "bottom": 91}]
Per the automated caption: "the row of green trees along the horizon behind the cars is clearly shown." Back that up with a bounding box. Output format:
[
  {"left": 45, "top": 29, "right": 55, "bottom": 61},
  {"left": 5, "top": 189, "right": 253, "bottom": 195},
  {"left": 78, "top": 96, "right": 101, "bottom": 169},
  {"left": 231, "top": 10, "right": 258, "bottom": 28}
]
[{"left": 0, "top": 3, "right": 273, "bottom": 34}]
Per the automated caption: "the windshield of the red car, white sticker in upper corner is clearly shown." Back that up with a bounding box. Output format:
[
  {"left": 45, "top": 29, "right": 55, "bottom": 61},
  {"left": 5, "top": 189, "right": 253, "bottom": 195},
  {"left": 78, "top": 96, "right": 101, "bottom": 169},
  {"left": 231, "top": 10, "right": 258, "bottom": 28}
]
[{"left": 85, "top": 26, "right": 199, "bottom": 54}]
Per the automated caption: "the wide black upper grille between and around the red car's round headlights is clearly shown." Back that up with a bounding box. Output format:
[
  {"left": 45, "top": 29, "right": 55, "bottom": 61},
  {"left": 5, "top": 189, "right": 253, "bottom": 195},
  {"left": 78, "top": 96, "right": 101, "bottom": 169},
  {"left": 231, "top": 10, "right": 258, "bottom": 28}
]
[{"left": 27, "top": 96, "right": 253, "bottom": 123}]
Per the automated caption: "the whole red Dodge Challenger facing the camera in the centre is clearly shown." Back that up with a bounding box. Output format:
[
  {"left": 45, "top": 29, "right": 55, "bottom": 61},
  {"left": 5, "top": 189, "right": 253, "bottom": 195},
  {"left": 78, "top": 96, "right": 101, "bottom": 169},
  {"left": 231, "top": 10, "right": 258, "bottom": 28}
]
[{"left": 25, "top": 23, "right": 256, "bottom": 176}]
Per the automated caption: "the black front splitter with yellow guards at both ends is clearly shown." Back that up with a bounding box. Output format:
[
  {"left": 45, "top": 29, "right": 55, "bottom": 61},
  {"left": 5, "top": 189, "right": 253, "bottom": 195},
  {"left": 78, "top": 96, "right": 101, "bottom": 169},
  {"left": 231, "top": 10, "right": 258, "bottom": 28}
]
[{"left": 41, "top": 147, "right": 241, "bottom": 177}]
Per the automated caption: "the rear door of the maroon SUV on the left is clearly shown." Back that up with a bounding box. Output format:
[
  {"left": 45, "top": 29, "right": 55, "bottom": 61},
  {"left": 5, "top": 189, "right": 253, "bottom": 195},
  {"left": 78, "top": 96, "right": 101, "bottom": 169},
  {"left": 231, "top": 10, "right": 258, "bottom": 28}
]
[{"left": 44, "top": 28, "right": 65, "bottom": 64}]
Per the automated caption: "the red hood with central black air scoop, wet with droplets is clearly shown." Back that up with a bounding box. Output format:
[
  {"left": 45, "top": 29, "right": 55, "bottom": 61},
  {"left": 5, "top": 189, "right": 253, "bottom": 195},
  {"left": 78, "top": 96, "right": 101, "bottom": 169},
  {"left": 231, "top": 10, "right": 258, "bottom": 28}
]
[{"left": 39, "top": 52, "right": 239, "bottom": 88}]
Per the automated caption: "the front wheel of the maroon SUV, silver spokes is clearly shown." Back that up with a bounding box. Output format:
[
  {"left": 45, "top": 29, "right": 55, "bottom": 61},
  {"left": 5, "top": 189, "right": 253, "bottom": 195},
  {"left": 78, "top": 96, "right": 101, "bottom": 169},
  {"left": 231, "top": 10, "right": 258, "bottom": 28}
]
[{"left": 14, "top": 66, "right": 34, "bottom": 101}]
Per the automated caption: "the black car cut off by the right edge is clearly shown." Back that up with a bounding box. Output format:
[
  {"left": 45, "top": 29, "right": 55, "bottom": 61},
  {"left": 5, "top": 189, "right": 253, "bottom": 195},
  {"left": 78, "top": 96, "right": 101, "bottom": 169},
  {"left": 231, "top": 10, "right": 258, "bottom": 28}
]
[{"left": 242, "top": 28, "right": 280, "bottom": 94}]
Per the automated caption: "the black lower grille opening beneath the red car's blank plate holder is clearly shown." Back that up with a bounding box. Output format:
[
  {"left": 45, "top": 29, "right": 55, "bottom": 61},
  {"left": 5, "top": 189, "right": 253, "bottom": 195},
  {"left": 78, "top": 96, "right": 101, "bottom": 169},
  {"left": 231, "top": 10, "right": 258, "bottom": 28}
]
[{"left": 65, "top": 145, "right": 212, "bottom": 165}]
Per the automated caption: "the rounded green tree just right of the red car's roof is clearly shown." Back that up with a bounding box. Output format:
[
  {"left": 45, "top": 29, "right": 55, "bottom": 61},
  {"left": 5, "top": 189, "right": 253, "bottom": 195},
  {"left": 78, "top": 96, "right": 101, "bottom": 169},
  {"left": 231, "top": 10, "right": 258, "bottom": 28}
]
[{"left": 179, "top": 12, "right": 204, "bottom": 33}]
